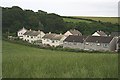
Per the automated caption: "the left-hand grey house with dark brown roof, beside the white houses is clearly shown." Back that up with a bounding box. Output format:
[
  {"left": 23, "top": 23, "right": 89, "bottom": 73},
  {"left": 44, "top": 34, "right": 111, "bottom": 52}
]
[{"left": 63, "top": 35, "right": 87, "bottom": 50}]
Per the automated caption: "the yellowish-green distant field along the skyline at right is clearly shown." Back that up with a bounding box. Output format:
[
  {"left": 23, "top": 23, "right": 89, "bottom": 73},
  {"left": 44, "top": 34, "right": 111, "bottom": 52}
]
[{"left": 73, "top": 16, "right": 118, "bottom": 24}]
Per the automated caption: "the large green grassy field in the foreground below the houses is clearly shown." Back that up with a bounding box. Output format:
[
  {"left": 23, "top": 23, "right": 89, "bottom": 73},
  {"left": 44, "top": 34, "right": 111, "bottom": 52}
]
[{"left": 2, "top": 41, "right": 118, "bottom": 78}]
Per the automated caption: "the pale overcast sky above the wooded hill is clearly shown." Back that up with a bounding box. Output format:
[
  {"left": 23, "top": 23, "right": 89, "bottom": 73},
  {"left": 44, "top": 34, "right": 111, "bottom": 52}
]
[{"left": 0, "top": 0, "right": 119, "bottom": 17}]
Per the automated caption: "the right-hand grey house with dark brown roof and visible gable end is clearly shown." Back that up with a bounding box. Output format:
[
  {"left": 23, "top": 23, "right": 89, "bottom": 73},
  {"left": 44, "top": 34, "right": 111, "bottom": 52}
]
[{"left": 84, "top": 36, "right": 117, "bottom": 51}]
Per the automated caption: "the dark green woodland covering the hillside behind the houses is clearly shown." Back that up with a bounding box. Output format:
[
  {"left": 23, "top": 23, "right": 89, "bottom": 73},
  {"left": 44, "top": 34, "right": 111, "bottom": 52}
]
[{"left": 2, "top": 6, "right": 119, "bottom": 35}]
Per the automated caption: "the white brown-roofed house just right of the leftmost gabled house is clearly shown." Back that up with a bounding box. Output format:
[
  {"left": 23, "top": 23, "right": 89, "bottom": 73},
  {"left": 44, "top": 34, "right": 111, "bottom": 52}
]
[{"left": 23, "top": 29, "right": 45, "bottom": 43}]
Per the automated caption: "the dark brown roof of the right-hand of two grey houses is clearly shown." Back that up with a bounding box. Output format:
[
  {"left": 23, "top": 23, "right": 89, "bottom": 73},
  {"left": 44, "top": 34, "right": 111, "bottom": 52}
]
[{"left": 86, "top": 36, "right": 113, "bottom": 43}]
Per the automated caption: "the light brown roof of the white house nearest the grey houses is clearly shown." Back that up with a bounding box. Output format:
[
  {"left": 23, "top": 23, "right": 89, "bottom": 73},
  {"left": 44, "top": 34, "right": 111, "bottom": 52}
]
[{"left": 43, "top": 33, "right": 64, "bottom": 40}]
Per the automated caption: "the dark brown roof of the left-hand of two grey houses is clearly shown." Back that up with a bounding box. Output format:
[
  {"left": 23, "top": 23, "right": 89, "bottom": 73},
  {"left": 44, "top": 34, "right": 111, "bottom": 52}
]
[{"left": 65, "top": 35, "right": 87, "bottom": 43}]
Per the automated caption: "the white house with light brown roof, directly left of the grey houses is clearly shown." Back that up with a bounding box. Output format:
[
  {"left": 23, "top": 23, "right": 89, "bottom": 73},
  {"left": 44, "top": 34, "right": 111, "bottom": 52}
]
[{"left": 42, "top": 33, "right": 66, "bottom": 47}]
